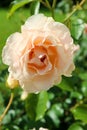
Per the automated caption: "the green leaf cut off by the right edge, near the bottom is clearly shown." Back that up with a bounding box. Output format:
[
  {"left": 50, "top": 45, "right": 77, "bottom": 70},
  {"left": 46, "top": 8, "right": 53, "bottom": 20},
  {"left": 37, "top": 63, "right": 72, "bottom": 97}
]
[{"left": 71, "top": 104, "right": 87, "bottom": 123}]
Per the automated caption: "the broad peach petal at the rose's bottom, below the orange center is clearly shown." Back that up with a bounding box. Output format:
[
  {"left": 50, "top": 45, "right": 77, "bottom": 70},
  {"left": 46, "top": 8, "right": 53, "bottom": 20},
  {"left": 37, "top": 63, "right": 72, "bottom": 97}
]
[{"left": 33, "top": 68, "right": 61, "bottom": 91}]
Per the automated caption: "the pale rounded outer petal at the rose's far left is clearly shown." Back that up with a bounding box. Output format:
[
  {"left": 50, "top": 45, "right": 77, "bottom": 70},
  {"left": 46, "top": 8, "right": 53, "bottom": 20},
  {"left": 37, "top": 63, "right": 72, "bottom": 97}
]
[{"left": 2, "top": 32, "right": 33, "bottom": 65}]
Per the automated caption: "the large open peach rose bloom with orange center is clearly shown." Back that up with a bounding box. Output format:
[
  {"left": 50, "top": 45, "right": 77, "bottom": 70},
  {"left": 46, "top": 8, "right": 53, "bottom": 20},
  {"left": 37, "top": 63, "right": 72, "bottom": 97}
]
[{"left": 2, "top": 14, "right": 77, "bottom": 93}]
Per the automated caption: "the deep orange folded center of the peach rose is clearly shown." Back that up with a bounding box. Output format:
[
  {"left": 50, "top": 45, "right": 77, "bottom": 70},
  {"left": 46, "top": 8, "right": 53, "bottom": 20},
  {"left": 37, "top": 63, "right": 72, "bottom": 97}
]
[{"left": 28, "top": 46, "right": 48, "bottom": 70}]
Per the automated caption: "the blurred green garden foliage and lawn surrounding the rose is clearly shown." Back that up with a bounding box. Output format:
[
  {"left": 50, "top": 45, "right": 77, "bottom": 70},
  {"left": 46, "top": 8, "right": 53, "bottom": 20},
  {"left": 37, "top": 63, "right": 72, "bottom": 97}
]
[{"left": 0, "top": 0, "right": 87, "bottom": 130}]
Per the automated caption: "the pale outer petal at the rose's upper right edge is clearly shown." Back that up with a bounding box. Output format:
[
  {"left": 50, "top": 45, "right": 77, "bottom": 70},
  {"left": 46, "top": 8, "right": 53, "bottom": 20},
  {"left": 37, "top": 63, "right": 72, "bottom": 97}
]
[{"left": 45, "top": 21, "right": 73, "bottom": 51}]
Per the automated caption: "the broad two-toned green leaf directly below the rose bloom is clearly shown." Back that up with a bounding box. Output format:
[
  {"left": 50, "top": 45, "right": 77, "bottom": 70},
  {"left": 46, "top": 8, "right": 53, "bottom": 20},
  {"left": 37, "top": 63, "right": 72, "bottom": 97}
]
[{"left": 25, "top": 91, "right": 48, "bottom": 120}]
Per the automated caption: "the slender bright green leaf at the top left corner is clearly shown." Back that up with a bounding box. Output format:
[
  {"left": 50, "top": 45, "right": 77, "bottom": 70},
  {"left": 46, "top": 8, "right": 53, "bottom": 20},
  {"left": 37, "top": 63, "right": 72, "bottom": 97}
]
[{"left": 8, "top": 0, "right": 35, "bottom": 18}]
